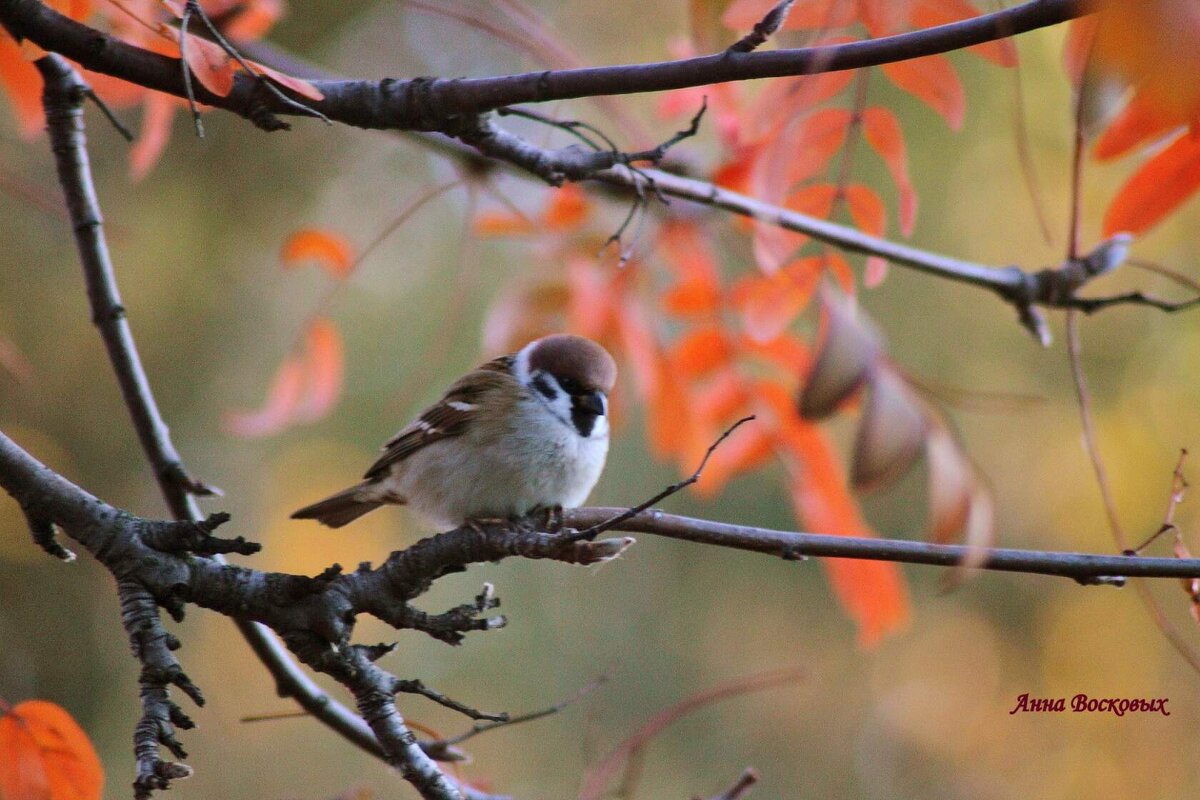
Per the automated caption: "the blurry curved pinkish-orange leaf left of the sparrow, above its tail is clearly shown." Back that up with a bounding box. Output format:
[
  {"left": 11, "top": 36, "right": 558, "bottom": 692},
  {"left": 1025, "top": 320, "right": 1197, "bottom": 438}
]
[{"left": 224, "top": 318, "right": 344, "bottom": 439}]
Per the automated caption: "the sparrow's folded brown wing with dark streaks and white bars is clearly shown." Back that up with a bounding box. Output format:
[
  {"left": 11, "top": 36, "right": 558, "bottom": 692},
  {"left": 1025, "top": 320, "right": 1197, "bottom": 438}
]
[{"left": 364, "top": 356, "right": 515, "bottom": 481}]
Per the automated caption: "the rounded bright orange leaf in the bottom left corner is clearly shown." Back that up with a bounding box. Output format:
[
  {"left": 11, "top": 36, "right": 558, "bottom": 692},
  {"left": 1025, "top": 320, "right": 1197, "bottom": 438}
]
[{"left": 0, "top": 700, "right": 104, "bottom": 800}]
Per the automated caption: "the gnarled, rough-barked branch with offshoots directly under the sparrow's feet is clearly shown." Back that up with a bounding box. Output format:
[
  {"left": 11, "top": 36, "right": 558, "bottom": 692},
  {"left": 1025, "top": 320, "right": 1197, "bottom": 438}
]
[{"left": 0, "top": 433, "right": 632, "bottom": 800}]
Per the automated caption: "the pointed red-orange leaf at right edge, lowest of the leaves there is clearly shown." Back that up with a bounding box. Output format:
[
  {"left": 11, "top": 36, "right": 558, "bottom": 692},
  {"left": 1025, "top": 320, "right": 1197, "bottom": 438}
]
[{"left": 1104, "top": 133, "right": 1200, "bottom": 236}]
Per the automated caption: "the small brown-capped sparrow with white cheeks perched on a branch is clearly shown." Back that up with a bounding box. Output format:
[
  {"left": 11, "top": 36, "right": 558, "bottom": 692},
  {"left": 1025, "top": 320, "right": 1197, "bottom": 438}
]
[{"left": 285, "top": 333, "right": 617, "bottom": 528}]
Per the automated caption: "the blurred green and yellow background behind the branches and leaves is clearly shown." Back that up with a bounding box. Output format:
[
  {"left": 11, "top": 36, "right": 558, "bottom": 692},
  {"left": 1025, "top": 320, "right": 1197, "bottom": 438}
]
[{"left": 0, "top": 0, "right": 1200, "bottom": 799}]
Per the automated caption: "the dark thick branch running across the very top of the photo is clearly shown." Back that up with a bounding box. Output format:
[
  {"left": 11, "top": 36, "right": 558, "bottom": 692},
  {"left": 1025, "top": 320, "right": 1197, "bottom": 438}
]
[{"left": 0, "top": 0, "right": 1084, "bottom": 133}]
